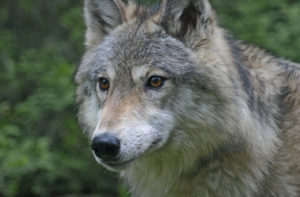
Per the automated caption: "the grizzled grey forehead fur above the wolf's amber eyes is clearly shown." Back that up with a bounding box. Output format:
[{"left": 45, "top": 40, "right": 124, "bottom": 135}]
[{"left": 86, "top": 29, "right": 195, "bottom": 74}]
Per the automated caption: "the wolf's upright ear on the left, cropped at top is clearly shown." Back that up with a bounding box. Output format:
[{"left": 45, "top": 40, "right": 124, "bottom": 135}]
[{"left": 84, "top": 0, "right": 124, "bottom": 47}]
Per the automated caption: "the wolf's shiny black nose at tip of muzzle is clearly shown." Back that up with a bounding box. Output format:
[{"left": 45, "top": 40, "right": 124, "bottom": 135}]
[{"left": 92, "top": 133, "right": 120, "bottom": 159}]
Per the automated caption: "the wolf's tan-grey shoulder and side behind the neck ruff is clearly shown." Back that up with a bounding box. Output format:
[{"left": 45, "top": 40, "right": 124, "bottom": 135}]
[{"left": 236, "top": 38, "right": 300, "bottom": 190}]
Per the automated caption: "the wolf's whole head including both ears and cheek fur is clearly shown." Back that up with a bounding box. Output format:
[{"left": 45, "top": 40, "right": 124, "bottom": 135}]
[{"left": 75, "top": 0, "right": 241, "bottom": 170}]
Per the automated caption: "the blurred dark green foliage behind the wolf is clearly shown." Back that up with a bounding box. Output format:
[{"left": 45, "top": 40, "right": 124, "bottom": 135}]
[{"left": 0, "top": 0, "right": 300, "bottom": 197}]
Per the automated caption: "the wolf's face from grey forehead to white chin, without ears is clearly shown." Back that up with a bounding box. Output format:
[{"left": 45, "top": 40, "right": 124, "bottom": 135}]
[{"left": 84, "top": 30, "right": 197, "bottom": 170}]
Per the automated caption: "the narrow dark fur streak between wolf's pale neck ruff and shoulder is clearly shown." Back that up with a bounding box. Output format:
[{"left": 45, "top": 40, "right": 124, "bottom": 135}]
[{"left": 227, "top": 38, "right": 255, "bottom": 110}]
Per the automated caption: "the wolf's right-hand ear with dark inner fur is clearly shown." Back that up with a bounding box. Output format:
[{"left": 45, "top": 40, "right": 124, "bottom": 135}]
[{"left": 161, "top": 0, "right": 216, "bottom": 48}]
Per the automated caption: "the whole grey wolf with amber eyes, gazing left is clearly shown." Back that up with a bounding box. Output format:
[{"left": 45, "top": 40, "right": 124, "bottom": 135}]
[{"left": 75, "top": 0, "right": 300, "bottom": 197}]
